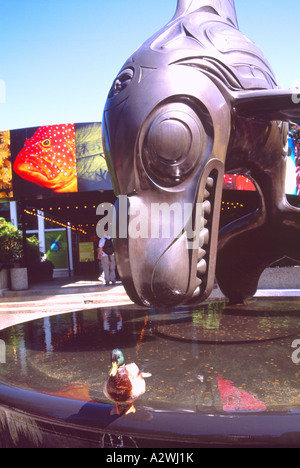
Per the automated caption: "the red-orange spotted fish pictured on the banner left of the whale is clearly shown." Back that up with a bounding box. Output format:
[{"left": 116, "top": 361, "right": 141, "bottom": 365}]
[{"left": 13, "top": 124, "right": 78, "bottom": 193}]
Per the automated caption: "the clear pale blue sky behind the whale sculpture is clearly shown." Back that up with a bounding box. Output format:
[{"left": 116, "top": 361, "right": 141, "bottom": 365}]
[{"left": 0, "top": 0, "right": 300, "bottom": 130}]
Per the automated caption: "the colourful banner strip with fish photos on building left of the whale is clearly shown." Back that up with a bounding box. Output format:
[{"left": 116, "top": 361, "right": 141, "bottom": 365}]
[{"left": 0, "top": 122, "right": 112, "bottom": 199}]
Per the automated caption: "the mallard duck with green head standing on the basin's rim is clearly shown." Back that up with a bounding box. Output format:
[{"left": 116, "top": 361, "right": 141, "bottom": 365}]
[{"left": 103, "top": 349, "right": 151, "bottom": 414}]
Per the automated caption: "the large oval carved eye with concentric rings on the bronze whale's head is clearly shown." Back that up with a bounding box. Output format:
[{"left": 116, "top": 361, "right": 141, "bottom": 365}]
[{"left": 140, "top": 103, "right": 212, "bottom": 187}]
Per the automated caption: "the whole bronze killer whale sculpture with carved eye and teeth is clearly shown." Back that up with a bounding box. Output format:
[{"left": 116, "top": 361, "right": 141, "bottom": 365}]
[{"left": 103, "top": 0, "right": 300, "bottom": 307}]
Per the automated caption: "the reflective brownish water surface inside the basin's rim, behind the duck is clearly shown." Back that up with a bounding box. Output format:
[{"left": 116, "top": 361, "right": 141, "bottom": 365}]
[{"left": 0, "top": 298, "right": 300, "bottom": 412}]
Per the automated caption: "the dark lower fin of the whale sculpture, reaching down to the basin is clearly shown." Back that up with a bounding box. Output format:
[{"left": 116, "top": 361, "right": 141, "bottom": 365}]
[{"left": 216, "top": 211, "right": 300, "bottom": 304}]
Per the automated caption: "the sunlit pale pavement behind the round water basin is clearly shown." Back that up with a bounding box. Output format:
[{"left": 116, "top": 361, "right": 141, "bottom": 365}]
[{"left": 0, "top": 277, "right": 300, "bottom": 330}]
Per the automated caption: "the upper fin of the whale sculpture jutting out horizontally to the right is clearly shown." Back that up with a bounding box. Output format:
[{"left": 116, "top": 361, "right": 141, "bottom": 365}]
[{"left": 233, "top": 89, "right": 300, "bottom": 125}]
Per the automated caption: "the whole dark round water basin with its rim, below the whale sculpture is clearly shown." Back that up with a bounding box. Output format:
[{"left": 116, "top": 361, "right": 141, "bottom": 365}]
[{"left": 0, "top": 298, "right": 300, "bottom": 448}]
